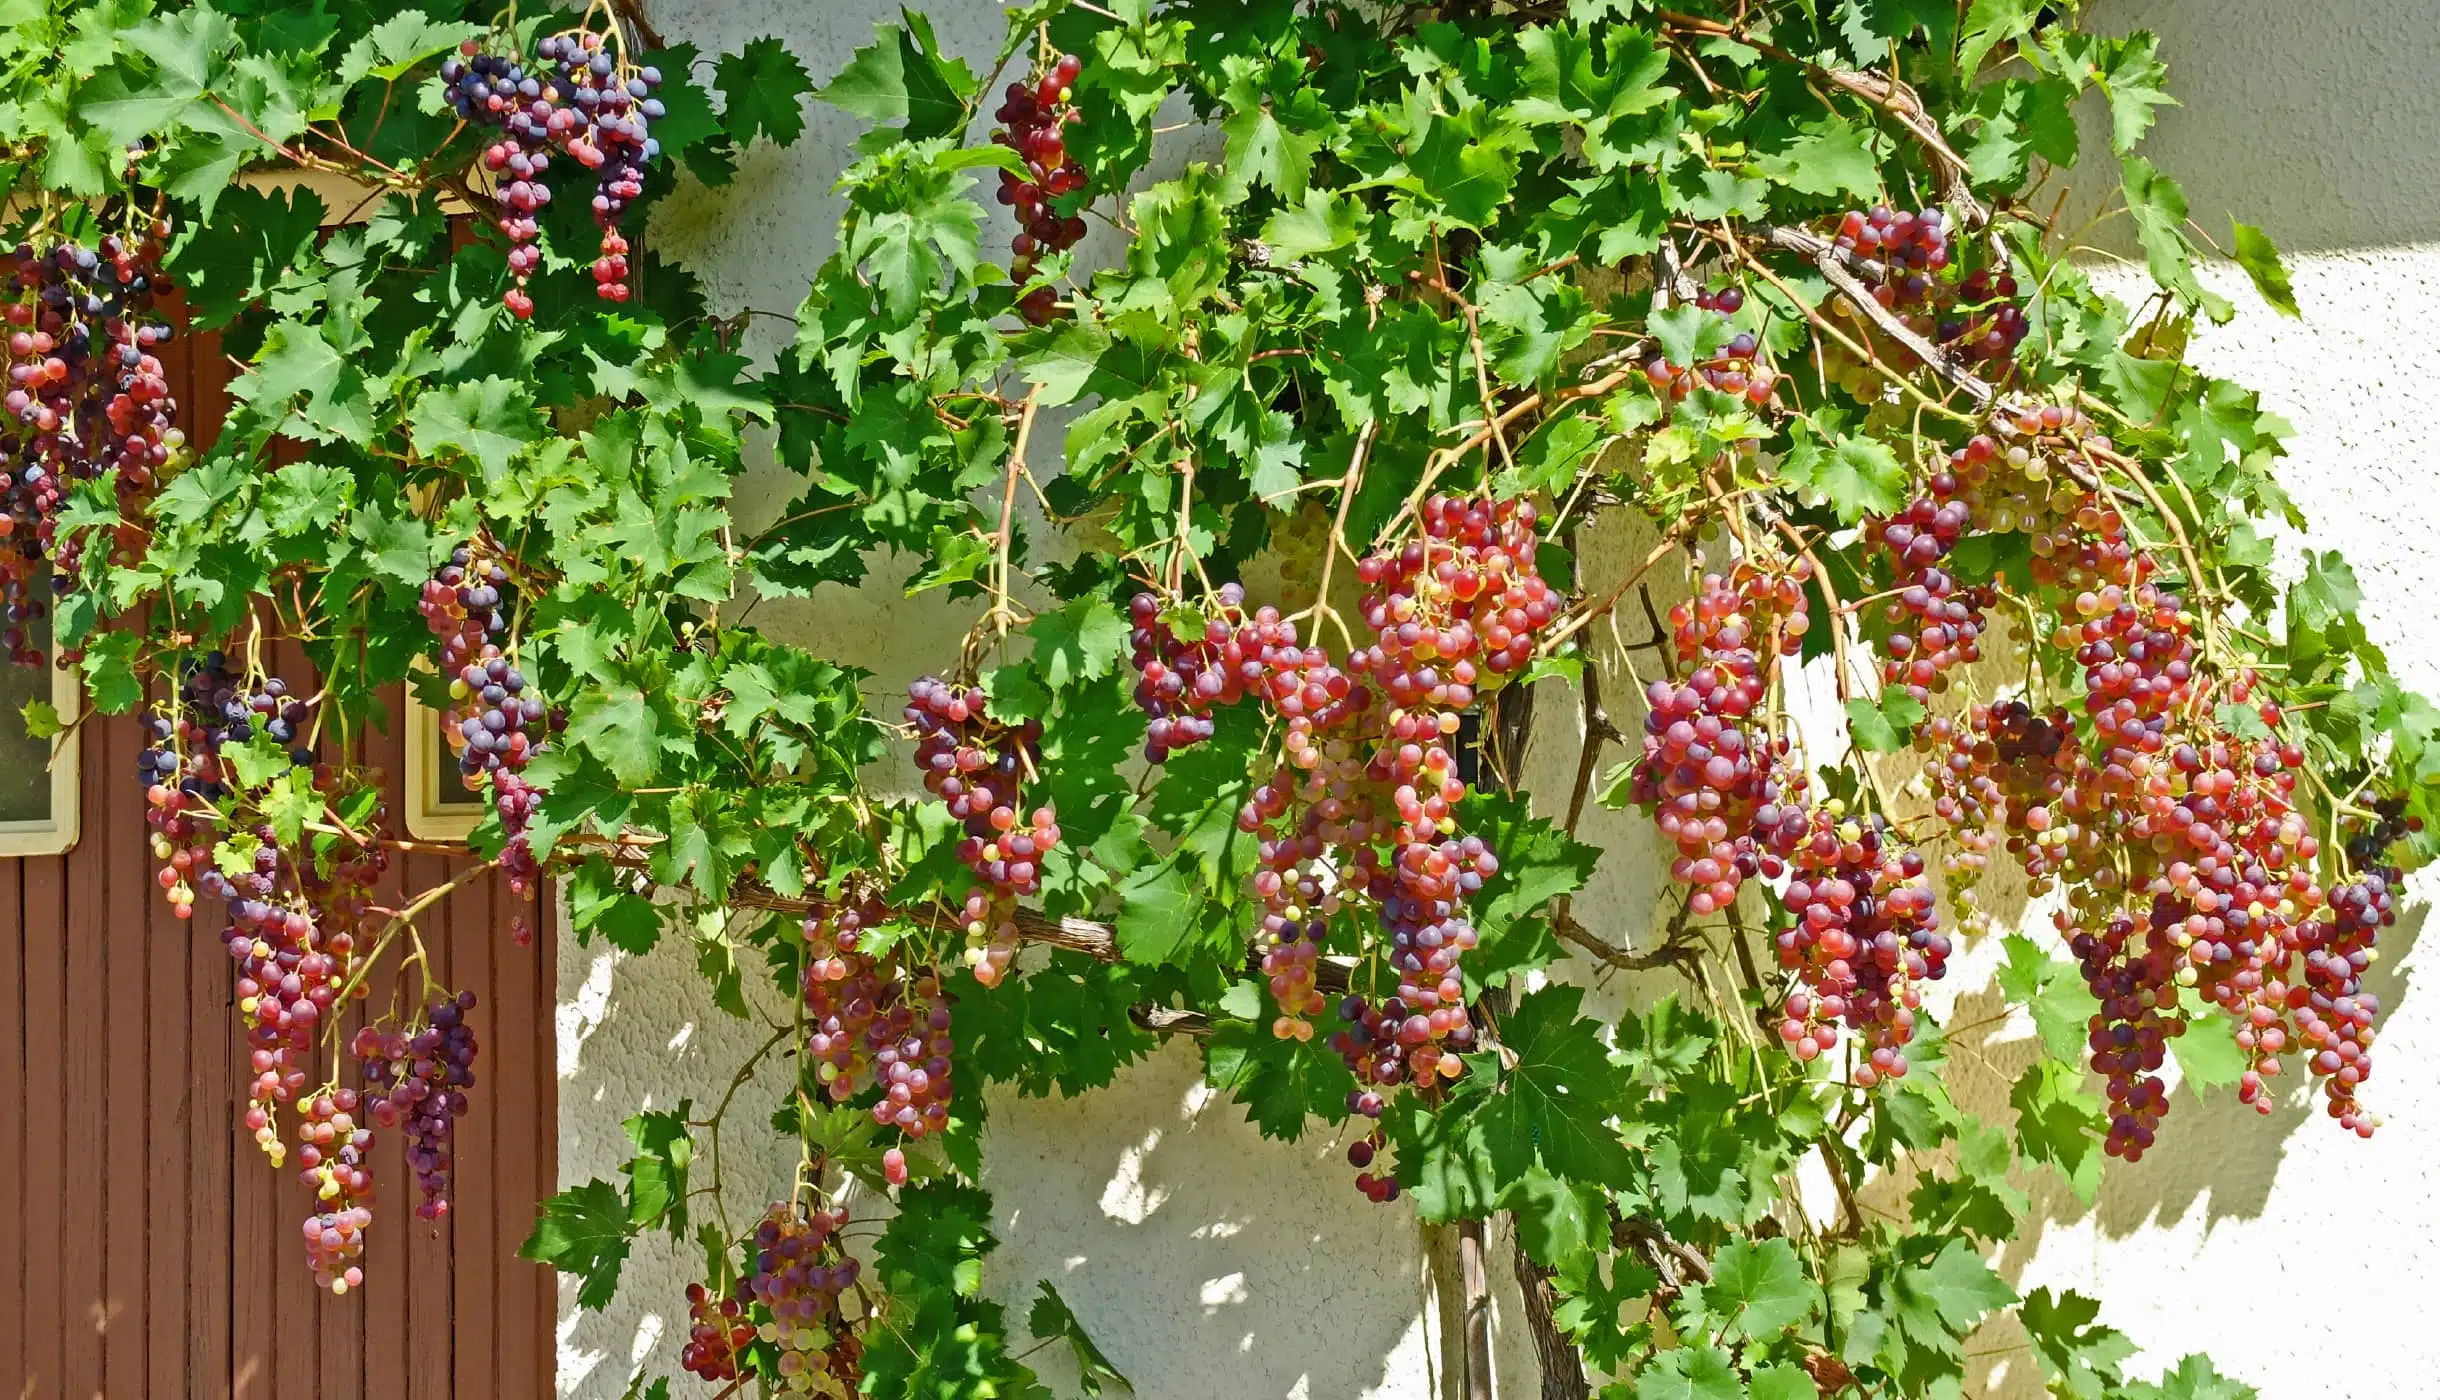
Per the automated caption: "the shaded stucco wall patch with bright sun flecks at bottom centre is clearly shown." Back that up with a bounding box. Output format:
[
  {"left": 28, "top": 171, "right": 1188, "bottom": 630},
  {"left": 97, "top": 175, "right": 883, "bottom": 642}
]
[{"left": 983, "top": 1041, "right": 1532, "bottom": 1400}]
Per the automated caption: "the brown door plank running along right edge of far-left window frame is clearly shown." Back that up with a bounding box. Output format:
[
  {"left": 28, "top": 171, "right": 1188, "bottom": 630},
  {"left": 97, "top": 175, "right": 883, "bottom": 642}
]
[{"left": 59, "top": 746, "right": 109, "bottom": 1398}]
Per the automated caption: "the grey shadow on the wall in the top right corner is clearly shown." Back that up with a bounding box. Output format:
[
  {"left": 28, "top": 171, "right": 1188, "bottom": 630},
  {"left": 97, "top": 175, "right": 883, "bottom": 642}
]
[{"left": 2086, "top": 0, "right": 2440, "bottom": 251}]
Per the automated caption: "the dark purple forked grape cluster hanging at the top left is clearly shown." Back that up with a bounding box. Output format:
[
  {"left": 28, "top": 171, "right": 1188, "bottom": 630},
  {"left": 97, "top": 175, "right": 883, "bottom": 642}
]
[{"left": 442, "top": 29, "right": 666, "bottom": 320}]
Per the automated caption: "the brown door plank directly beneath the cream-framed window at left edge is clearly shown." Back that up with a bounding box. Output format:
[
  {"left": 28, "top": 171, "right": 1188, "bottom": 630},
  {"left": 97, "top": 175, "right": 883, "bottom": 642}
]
[{"left": 15, "top": 856, "right": 68, "bottom": 1395}]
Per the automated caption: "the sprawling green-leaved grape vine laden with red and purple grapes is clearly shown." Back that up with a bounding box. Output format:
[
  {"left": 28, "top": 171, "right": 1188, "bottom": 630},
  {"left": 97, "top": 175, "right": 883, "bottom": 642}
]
[{"left": 0, "top": 0, "right": 2440, "bottom": 1400}]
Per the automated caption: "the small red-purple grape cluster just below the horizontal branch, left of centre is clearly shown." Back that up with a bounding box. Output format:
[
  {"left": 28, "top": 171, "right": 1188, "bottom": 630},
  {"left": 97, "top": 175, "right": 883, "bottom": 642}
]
[{"left": 803, "top": 905, "right": 956, "bottom": 1151}]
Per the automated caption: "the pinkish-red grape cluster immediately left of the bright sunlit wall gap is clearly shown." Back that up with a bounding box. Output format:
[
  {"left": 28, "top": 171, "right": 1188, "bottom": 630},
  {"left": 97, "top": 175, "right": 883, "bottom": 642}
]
[{"left": 1630, "top": 561, "right": 1810, "bottom": 915}]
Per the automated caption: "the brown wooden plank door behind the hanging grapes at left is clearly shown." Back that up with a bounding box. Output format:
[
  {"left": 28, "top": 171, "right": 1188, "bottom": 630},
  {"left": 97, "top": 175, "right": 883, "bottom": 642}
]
[{"left": 0, "top": 321, "right": 559, "bottom": 1400}]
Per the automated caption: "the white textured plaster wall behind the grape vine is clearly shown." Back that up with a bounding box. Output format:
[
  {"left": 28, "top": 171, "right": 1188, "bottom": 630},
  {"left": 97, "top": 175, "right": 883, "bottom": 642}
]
[{"left": 559, "top": 0, "right": 2440, "bottom": 1400}]
